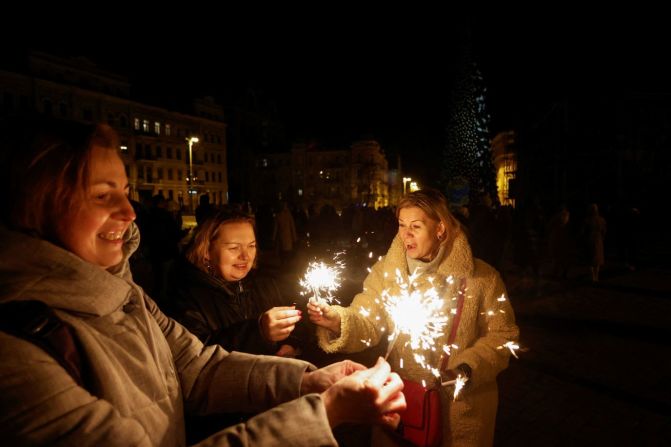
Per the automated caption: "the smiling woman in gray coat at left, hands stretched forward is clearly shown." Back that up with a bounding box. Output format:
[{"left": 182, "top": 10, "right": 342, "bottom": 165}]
[{"left": 0, "top": 121, "right": 405, "bottom": 446}]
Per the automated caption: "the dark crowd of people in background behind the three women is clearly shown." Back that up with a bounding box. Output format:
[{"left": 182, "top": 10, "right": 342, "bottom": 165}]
[{"left": 133, "top": 190, "right": 641, "bottom": 312}]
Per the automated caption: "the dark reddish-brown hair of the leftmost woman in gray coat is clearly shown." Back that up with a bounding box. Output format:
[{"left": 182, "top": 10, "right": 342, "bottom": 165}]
[{"left": 0, "top": 118, "right": 119, "bottom": 241}]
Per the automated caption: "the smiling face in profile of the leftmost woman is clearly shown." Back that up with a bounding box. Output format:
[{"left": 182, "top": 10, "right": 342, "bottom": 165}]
[{"left": 56, "top": 146, "right": 135, "bottom": 268}]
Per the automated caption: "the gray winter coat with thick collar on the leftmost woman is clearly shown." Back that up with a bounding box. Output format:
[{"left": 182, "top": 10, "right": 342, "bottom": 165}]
[{"left": 0, "top": 225, "right": 335, "bottom": 447}]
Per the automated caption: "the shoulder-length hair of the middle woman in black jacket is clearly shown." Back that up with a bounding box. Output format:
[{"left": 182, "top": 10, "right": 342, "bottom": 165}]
[{"left": 186, "top": 207, "right": 256, "bottom": 273}]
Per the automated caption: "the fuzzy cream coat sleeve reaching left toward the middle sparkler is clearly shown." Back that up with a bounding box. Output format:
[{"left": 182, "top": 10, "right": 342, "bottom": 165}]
[{"left": 317, "top": 261, "right": 389, "bottom": 353}]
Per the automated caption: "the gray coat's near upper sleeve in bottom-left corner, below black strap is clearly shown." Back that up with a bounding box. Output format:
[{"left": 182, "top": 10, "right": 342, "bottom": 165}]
[{"left": 0, "top": 332, "right": 151, "bottom": 447}]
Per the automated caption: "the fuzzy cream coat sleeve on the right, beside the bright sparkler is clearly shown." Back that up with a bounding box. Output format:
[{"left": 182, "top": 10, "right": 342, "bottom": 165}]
[{"left": 449, "top": 264, "right": 519, "bottom": 386}]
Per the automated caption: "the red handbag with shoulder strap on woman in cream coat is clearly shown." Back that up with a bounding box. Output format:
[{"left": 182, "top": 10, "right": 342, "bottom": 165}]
[{"left": 401, "top": 278, "right": 466, "bottom": 447}]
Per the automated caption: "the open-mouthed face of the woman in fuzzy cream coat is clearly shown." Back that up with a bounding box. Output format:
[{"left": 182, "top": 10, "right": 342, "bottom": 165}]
[{"left": 398, "top": 206, "right": 445, "bottom": 261}]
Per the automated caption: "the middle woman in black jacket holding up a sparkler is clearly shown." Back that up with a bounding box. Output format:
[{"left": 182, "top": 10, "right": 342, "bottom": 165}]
[{"left": 173, "top": 208, "right": 301, "bottom": 357}]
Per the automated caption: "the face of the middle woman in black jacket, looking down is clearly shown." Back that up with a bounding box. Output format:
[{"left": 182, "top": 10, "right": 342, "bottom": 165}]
[{"left": 209, "top": 222, "right": 256, "bottom": 281}]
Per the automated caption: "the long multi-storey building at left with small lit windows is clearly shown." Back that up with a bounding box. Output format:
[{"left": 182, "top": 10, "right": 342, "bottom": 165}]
[{"left": 0, "top": 53, "right": 228, "bottom": 210}]
